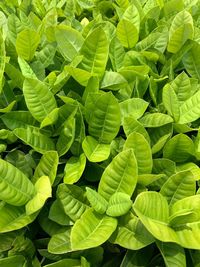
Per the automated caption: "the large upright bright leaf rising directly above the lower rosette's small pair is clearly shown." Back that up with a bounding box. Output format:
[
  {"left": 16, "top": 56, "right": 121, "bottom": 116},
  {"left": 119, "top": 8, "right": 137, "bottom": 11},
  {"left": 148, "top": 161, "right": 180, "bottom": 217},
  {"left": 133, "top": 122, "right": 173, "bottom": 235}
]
[{"left": 98, "top": 149, "right": 138, "bottom": 201}]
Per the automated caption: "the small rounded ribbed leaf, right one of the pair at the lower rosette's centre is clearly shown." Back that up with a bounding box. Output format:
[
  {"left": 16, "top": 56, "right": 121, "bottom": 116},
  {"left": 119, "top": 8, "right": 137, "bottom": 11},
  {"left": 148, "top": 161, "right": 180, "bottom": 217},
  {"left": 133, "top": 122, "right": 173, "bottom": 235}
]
[{"left": 106, "top": 192, "right": 132, "bottom": 217}]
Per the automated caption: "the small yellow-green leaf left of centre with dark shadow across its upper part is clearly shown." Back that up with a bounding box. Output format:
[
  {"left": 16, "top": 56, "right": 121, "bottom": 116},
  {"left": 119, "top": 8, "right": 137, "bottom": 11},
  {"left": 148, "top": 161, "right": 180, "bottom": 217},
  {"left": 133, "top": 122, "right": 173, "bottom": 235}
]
[{"left": 63, "top": 154, "right": 86, "bottom": 184}]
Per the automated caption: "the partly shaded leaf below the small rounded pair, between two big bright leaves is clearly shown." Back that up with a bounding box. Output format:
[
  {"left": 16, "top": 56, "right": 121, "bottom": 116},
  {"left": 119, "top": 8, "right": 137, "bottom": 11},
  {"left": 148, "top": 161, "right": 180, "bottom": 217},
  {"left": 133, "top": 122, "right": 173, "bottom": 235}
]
[{"left": 109, "top": 212, "right": 154, "bottom": 250}]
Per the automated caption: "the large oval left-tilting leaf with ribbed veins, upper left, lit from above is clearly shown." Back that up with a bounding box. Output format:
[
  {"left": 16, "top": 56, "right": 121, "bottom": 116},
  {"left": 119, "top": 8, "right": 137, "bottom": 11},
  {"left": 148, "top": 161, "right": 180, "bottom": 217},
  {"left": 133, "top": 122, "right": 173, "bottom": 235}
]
[{"left": 23, "top": 78, "right": 57, "bottom": 122}]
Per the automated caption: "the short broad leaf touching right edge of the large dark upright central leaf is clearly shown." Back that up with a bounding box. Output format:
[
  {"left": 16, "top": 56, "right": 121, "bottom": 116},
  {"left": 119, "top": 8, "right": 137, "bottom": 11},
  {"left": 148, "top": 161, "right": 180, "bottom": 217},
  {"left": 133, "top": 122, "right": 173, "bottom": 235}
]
[{"left": 120, "top": 98, "right": 149, "bottom": 122}]
